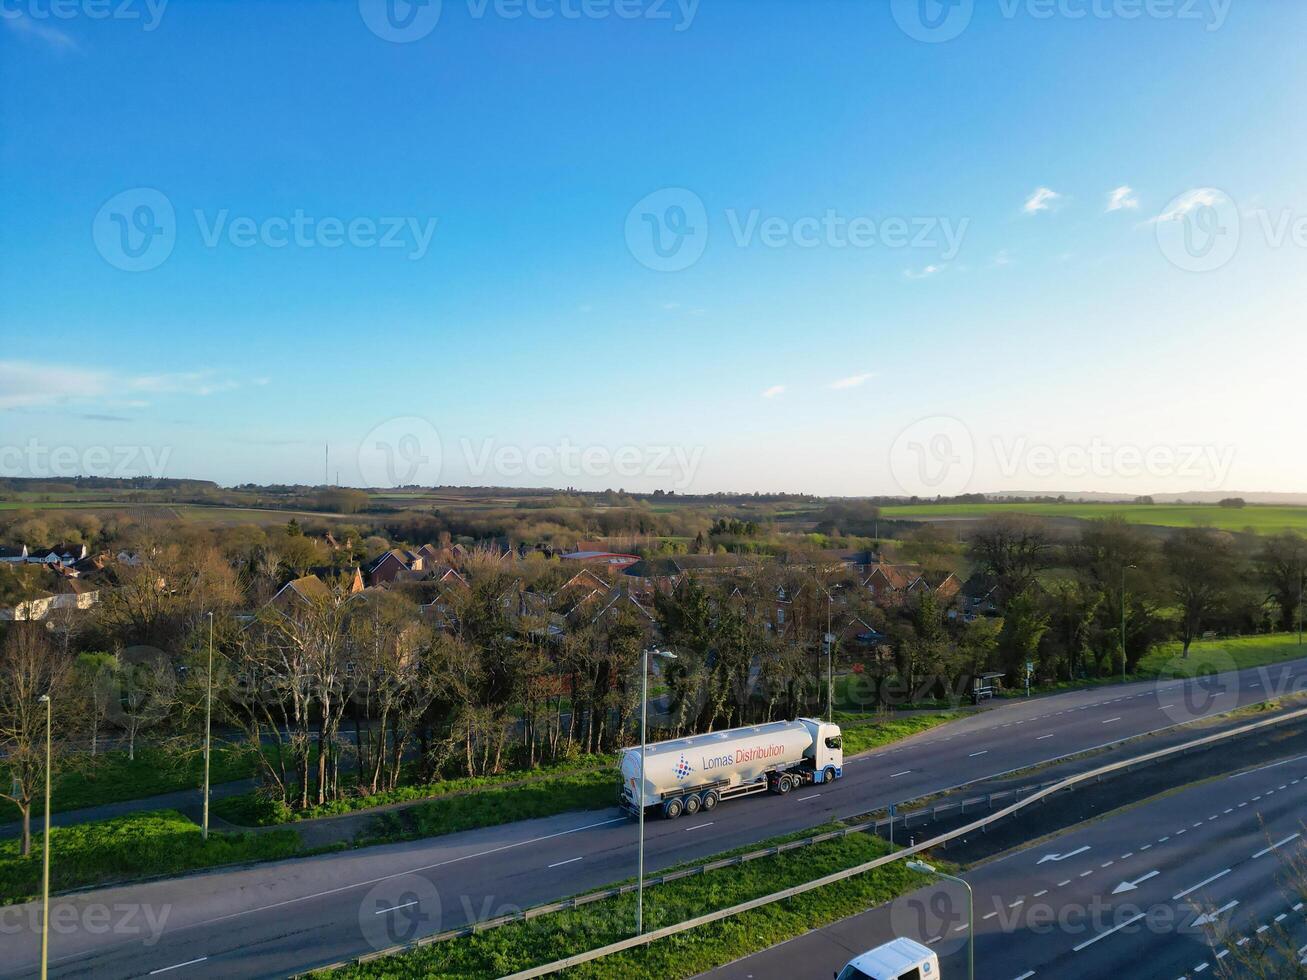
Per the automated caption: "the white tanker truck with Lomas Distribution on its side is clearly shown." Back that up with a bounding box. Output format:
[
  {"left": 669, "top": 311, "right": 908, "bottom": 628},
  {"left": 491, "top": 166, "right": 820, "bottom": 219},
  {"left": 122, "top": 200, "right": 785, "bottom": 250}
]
[{"left": 621, "top": 717, "right": 844, "bottom": 819}]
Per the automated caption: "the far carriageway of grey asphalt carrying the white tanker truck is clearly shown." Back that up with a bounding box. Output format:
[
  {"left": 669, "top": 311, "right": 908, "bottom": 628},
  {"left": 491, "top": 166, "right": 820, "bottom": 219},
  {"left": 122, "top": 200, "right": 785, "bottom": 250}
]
[{"left": 0, "top": 661, "right": 1307, "bottom": 977}]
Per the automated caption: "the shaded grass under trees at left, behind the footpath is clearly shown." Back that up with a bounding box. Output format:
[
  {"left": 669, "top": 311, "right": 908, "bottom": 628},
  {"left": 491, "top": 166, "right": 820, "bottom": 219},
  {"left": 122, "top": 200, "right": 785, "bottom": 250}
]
[{"left": 0, "top": 747, "right": 254, "bottom": 823}]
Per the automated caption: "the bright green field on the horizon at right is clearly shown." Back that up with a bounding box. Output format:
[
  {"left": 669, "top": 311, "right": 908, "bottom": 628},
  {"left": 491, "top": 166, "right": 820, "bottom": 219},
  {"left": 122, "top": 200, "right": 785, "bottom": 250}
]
[{"left": 881, "top": 503, "right": 1307, "bottom": 534}]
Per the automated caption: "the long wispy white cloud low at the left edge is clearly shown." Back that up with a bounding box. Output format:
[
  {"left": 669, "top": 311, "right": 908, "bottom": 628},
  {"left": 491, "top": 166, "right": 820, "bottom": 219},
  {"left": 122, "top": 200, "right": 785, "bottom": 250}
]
[{"left": 0, "top": 361, "right": 240, "bottom": 408}]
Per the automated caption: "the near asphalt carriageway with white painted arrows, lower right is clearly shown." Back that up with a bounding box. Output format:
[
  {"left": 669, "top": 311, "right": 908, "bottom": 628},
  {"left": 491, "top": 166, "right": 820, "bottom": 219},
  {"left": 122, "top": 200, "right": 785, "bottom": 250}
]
[{"left": 703, "top": 757, "right": 1307, "bottom": 980}]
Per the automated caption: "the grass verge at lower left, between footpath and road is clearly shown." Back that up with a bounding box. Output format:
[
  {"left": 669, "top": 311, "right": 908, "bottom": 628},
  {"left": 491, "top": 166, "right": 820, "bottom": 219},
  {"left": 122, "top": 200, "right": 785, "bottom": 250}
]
[{"left": 0, "top": 810, "right": 302, "bottom": 904}]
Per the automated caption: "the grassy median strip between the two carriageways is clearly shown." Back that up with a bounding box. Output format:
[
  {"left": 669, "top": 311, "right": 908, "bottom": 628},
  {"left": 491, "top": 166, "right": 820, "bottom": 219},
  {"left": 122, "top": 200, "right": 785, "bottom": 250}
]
[{"left": 320, "top": 834, "right": 924, "bottom": 980}]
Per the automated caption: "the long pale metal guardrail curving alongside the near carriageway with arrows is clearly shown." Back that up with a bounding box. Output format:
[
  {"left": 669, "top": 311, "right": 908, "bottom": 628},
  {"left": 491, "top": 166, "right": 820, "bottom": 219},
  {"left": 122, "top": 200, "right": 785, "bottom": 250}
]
[{"left": 502, "top": 708, "right": 1307, "bottom": 980}]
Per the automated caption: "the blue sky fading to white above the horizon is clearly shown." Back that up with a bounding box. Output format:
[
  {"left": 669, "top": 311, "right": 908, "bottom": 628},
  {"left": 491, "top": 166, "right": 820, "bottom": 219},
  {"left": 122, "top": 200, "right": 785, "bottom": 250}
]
[{"left": 0, "top": 0, "right": 1307, "bottom": 494}]
